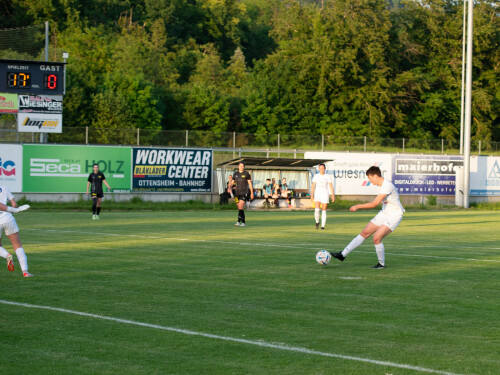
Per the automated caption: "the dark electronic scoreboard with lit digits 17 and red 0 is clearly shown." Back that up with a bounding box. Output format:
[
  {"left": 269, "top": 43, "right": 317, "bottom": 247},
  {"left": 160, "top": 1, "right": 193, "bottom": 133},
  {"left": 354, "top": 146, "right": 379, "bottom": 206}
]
[{"left": 0, "top": 59, "right": 65, "bottom": 95}]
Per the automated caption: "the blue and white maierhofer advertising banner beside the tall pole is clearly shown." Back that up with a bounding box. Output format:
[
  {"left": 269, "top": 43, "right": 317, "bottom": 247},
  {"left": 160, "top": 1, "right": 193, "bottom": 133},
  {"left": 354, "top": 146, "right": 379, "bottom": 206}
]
[{"left": 392, "top": 155, "right": 463, "bottom": 195}]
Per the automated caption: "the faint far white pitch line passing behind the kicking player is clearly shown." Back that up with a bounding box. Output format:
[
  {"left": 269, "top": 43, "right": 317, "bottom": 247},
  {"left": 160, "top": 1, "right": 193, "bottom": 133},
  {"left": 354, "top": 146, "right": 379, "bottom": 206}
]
[{"left": 23, "top": 228, "right": 500, "bottom": 263}]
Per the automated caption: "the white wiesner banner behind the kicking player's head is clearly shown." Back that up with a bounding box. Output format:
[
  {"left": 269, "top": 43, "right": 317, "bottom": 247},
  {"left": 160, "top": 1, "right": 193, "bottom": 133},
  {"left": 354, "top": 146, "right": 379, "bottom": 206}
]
[{"left": 304, "top": 152, "right": 392, "bottom": 195}]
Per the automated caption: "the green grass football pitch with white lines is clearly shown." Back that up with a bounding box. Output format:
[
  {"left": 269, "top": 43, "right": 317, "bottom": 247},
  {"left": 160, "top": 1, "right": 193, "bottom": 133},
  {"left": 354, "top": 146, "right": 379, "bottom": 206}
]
[{"left": 0, "top": 210, "right": 500, "bottom": 375}]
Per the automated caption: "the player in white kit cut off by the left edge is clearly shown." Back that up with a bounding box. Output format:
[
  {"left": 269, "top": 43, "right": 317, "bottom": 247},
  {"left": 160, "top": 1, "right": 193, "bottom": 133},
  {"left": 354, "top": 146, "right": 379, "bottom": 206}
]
[{"left": 0, "top": 185, "right": 33, "bottom": 277}]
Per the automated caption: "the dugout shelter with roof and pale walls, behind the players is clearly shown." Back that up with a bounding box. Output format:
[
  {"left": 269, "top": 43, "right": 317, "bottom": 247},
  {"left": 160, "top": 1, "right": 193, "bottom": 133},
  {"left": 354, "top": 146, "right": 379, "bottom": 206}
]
[{"left": 217, "top": 156, "right": 331, "bottom": 207}]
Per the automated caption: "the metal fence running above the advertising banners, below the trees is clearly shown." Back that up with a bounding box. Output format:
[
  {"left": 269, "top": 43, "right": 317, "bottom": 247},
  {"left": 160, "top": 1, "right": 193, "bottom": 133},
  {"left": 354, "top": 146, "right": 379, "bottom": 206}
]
[{"left": 0, "top": 127, "right": 500, "bottom": 157}]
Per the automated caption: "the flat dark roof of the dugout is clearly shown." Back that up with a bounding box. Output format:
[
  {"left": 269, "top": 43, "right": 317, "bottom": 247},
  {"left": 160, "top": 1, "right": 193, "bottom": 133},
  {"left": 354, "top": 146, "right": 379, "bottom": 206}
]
[{"left": 218, "top": 156, "right": 331, "bottom": 170}]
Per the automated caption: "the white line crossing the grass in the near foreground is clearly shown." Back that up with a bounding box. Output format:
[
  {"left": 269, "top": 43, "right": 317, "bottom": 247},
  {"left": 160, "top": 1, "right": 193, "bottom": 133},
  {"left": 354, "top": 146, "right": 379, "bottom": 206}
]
[{"left": 0, "top": 300, "right": 459, "bottom": 375}]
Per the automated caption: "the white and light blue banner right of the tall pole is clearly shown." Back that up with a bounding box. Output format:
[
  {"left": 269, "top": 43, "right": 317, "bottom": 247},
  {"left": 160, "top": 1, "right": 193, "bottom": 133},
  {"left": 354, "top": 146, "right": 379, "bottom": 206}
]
[{"left": 470, "top": 156, "right": 500, "bottom": 196}]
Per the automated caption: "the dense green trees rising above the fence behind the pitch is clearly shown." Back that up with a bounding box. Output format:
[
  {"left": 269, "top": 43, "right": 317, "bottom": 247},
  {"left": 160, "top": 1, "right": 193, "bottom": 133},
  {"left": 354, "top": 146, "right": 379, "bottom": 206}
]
[{"left": 0, "top": 0, "right": 500, "bottom": 141}]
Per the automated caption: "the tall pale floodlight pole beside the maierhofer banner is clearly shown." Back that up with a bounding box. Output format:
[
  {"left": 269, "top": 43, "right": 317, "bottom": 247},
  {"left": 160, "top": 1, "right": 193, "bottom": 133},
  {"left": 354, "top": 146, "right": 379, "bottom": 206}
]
[{"left": 464, "top": 0, "right": 474, "bottom": 208}]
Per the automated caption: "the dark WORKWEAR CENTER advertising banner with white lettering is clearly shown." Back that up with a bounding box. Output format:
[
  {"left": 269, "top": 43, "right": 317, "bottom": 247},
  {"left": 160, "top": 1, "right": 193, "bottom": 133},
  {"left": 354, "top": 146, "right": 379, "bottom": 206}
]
[{"left": 132, "top": 148, "right": 213, "bottom": 193}]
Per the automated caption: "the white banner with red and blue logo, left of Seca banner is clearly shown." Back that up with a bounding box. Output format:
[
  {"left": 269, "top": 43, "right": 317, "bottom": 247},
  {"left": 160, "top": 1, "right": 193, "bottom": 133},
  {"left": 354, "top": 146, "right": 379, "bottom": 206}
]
[{"left": 0, "top": 145, "right": 23, "bottom": 192}]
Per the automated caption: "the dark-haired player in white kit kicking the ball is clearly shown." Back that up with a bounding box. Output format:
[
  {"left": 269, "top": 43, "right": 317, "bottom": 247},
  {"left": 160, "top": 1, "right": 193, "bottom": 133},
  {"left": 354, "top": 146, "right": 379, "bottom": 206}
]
[{"left": 331, "top": 167, "right": 405, "bottom": 268}]
